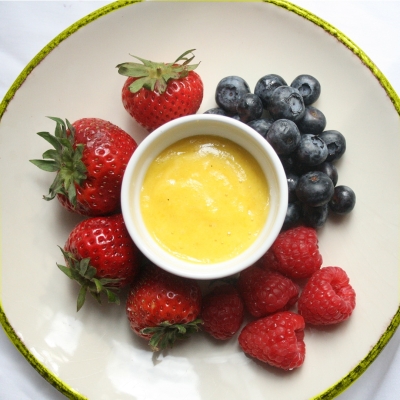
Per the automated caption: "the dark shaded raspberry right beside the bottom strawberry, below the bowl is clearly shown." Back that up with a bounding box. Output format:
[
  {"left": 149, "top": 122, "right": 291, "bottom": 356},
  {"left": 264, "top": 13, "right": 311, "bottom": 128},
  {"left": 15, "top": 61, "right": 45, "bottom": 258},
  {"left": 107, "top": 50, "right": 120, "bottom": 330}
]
[{"left": 201, "top": 283, "right": 244, "bottom": 340}]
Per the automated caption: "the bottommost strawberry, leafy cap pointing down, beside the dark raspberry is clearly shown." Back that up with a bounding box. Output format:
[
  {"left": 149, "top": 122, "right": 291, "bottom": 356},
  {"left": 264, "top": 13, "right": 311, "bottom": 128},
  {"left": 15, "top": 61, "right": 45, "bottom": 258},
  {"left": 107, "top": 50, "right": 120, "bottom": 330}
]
[{"left": 126, "top": 264, "right": 201, "bottom": 351}]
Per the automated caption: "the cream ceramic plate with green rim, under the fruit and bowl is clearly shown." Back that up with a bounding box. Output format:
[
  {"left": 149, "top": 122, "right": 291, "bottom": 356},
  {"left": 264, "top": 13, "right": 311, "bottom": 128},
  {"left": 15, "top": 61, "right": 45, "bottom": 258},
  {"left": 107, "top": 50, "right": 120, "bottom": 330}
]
[{"left": 0, "top": 1, "right": 400, "bottom": 400}]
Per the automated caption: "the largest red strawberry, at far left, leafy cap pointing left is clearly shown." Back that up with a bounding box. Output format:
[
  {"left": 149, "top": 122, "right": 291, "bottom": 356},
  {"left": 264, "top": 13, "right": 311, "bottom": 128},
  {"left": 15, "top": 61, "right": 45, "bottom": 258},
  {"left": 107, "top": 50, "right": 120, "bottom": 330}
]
[{"left": 30, "top": 117, "right": 137, "bottom": 217}]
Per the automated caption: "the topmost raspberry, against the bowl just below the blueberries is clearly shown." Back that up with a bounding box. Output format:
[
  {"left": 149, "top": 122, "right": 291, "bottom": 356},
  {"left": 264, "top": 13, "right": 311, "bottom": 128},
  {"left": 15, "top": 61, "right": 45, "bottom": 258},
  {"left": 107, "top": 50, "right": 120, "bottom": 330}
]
[{"left": 263, "top": 226, "right": 322, "bottom": 279}]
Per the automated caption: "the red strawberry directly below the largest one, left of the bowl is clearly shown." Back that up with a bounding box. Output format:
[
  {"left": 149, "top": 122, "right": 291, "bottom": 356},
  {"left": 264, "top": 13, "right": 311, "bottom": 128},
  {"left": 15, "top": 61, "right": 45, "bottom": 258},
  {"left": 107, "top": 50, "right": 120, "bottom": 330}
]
[{"left": 57, "top": 214, "right": 140, "bottom": 311}]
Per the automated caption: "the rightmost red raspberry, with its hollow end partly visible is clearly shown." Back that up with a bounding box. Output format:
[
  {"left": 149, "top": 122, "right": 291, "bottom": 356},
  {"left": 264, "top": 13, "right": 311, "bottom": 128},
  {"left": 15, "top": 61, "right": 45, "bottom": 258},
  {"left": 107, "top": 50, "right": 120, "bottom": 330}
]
[{"left": 298, "top": 267, "right": 356, "bottom": 325}]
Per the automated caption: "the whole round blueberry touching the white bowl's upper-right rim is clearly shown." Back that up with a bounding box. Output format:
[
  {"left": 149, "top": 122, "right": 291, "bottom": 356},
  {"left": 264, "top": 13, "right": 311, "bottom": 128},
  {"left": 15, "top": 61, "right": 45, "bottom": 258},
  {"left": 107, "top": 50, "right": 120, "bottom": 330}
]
[{"left": 266, "top": 119, "right": 300, "bottom": 155}]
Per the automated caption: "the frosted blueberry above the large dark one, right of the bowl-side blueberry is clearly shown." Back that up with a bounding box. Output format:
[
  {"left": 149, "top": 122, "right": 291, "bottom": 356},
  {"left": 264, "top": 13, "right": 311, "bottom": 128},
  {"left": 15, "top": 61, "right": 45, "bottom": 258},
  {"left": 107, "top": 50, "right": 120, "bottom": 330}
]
[{"left": 296, "top": 134, "right": 328, "bottom": 166}]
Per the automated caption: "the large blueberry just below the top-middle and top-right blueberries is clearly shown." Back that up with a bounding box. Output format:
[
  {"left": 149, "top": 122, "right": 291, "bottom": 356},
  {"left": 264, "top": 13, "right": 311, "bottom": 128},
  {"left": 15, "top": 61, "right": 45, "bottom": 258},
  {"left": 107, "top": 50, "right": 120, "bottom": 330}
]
[{"left": 267, "top": 86, "right": 305, "bottom": 122}]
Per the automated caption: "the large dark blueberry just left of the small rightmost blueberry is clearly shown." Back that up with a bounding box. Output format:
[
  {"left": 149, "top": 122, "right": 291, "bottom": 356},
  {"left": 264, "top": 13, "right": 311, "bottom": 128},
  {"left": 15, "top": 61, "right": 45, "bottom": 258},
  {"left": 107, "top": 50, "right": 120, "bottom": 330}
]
[{"left": 296, "top": 171, "right": 334, "bottom": 207}]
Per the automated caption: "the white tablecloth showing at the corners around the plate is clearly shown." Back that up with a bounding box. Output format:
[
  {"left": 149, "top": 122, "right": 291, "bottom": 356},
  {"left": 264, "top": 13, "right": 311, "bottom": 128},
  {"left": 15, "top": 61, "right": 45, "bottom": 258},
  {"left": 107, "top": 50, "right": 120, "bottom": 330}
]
[{"left": 0, "top": 0, "right": 400, "bottom": 400}]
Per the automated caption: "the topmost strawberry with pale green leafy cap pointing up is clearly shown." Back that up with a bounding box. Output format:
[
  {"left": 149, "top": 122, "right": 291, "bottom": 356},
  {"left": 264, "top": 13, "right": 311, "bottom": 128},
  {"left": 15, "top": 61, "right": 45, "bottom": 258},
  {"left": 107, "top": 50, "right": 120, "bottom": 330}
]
[{"left": 117, "top": 50, "right": 203, "bottom": 132}]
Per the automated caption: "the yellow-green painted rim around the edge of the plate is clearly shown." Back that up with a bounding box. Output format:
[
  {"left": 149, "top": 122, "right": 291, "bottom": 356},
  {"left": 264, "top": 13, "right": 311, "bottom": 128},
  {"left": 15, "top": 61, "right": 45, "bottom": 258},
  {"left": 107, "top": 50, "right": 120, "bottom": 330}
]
[{"left": 0, "top": 0, "right": 400, "bottom": 400}]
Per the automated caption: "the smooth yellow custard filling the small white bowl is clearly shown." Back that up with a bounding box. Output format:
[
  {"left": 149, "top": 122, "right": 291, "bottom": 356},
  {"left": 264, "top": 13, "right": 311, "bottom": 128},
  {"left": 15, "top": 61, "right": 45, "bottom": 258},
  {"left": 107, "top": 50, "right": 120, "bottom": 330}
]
[{"left": 140, "top": 135, "right": 269, "bottom": 263}]
